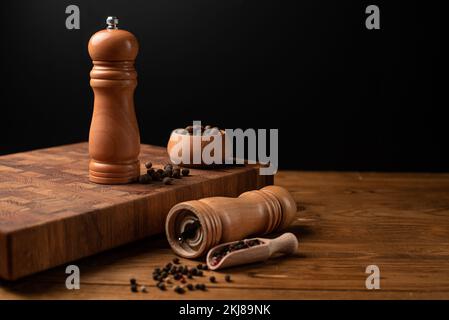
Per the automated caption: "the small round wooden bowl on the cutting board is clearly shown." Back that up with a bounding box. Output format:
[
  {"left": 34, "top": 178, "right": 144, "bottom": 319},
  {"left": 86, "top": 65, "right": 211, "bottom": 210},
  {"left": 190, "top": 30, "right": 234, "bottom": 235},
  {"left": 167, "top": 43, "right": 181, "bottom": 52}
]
[{"left": 167, "top": 129, "right": 228, "bottom": 168}]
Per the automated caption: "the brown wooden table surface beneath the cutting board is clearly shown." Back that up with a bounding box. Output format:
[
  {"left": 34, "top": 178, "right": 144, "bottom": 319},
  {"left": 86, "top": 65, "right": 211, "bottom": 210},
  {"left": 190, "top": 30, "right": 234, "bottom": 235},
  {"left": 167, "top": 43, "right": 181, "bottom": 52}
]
[{"left": 0, "top": 171, "right": 449, "bottom": 299}]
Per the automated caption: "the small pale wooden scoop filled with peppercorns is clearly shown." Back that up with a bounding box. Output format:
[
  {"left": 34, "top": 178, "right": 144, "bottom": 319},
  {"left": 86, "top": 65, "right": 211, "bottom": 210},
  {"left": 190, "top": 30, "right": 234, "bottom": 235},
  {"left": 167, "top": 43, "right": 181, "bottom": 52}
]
[{"left": 206, "top": 232, "right": 298, "bottom": 270}]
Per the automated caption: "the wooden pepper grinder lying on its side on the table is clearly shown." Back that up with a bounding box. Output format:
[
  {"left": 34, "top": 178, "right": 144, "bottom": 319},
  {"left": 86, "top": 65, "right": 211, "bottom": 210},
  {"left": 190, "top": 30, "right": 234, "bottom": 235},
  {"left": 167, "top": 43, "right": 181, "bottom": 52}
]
[{"left": 165, "top": 186, "right": 296, "bottom": 258}]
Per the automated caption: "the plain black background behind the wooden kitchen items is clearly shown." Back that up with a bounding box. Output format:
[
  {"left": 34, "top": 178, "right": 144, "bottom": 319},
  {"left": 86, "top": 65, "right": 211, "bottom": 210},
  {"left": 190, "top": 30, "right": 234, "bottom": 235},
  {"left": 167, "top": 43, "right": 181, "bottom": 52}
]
[{"left": 0, "top": 0, "right": 440, "bottom": 171}]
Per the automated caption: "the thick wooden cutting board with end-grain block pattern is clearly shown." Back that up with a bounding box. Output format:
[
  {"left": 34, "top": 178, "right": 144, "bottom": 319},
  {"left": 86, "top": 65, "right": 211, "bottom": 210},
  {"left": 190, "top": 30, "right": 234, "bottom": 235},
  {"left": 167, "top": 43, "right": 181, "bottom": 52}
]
[{"left": 0, "top": 143, "right": 273, "bottom": 280}]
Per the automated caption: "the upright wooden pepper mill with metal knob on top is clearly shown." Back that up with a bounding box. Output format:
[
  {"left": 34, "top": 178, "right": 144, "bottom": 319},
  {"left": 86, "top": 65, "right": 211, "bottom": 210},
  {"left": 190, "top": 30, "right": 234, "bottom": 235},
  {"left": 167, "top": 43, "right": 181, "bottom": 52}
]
[{"left": 88, "top": 17, "right": 140, "bottom": 184}]
